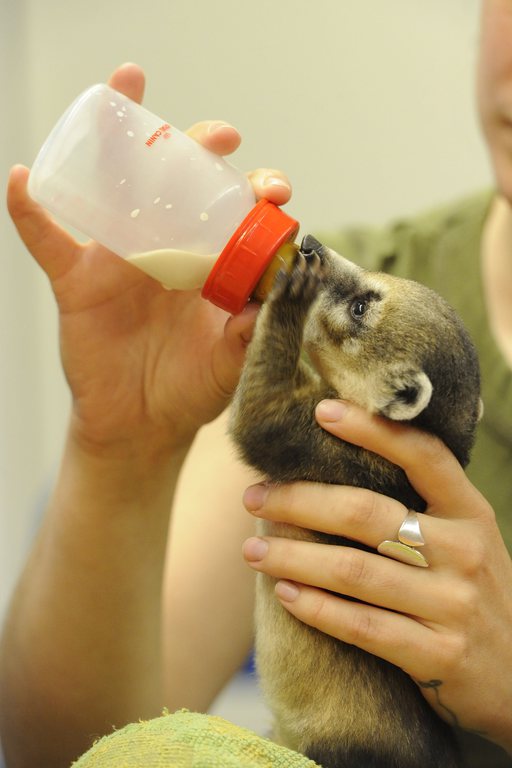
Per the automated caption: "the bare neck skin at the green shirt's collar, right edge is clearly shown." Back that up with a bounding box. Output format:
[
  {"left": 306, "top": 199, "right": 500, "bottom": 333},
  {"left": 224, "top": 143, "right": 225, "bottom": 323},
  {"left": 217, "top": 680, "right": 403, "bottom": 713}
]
[{"left": 482, "top": 196, "right": 512, "bottom": 368}]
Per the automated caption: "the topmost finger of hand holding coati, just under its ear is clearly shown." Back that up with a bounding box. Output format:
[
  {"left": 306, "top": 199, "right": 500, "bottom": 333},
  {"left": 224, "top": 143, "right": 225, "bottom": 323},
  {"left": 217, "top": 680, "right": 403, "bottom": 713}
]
[{"left": 316, "top": 400, "right": 483, "bottom": 517}]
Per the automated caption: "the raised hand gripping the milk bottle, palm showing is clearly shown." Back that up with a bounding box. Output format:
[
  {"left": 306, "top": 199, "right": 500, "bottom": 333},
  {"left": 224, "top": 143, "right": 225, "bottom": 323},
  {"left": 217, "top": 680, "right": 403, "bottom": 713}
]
[{"left": 8, "top": 64, "right": 290, "bottom": 455}]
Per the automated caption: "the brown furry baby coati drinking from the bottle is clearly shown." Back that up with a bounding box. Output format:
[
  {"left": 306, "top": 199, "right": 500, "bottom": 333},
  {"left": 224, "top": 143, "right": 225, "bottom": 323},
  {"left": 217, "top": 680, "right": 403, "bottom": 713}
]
[{"left": 231, "top": 236, "right": 480, "bottom": 768}]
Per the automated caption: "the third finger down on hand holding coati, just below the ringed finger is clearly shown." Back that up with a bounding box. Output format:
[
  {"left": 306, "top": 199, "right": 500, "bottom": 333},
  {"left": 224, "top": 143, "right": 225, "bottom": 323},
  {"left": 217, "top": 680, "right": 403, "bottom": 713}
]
[{"left": 243, "top": 536, "right": 446, "bottom": 624}]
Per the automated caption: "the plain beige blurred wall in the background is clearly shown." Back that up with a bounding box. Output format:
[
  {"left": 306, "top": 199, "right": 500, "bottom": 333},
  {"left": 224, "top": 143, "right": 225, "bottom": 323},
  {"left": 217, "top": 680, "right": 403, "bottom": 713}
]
[{"left": 0, "top": 0, "right": 489, "bottom": 610}]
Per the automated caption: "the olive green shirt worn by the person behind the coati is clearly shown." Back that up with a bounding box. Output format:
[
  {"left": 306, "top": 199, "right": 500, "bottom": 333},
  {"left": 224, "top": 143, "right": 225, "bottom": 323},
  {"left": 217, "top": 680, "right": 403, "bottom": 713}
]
[{"left": 319, "top": 192, "right": 512, "bottom": 768}]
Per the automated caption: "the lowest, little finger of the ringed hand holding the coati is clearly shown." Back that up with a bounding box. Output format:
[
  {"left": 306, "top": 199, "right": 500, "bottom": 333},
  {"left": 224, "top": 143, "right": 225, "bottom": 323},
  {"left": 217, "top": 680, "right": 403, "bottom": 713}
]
[{"left": 276, "top": 583, "right": 448, "bottom": 679}]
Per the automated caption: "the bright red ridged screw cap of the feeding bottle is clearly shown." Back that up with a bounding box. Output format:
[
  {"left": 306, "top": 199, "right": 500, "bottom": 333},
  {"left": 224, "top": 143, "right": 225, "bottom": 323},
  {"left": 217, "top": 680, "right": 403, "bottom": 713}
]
[{"left": 201, "top": 200, "right": 299, "bottom": 315}]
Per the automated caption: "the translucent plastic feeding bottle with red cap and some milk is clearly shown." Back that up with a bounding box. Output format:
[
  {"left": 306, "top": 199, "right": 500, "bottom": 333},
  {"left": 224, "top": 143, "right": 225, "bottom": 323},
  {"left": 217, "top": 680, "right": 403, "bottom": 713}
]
[{"left": 28, "top": 84, "right": 299, "bottom": 313}]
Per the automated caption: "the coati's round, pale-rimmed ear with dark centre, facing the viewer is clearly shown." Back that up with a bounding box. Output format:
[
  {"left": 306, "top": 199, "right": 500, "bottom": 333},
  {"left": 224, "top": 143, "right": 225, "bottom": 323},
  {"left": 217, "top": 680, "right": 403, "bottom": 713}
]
[{"left": 377, "top": 368, "right": 432, "bottom": 421}]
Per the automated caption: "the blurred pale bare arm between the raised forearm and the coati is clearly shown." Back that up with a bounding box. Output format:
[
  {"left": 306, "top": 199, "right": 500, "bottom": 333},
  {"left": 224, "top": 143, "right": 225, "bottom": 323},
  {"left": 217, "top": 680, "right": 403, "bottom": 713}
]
[{"left": 164, "top": 413, "right": 257, "bottom": 711}]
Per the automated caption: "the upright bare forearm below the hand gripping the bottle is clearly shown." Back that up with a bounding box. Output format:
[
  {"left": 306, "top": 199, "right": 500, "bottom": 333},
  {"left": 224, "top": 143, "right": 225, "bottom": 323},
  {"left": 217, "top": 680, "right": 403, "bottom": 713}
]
[{"left": 0, "top": 426, "right": 185, "bottom": 768}]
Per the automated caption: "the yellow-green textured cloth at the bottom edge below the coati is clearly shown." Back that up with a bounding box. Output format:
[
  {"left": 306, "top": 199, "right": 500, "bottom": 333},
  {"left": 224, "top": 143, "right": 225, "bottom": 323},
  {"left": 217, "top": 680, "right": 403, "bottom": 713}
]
[{"left": 73, "top": 709, "right": 319, "bottom": 768}]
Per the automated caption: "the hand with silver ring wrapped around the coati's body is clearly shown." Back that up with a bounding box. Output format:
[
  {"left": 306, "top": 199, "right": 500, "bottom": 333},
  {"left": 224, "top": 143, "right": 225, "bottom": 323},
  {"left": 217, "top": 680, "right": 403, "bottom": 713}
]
[{"left": 244, "top": 401, "right": 512, "bottom": 754}]
